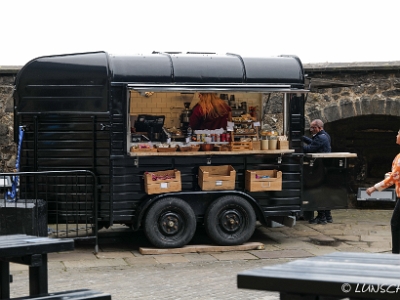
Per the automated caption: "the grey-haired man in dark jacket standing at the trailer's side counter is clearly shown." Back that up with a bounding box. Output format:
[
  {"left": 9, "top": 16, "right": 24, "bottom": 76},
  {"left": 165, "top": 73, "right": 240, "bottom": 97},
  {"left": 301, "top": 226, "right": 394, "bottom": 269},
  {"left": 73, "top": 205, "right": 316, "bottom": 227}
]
[{"left": 303, "top": 119, "right": 333, "bottom": 224}]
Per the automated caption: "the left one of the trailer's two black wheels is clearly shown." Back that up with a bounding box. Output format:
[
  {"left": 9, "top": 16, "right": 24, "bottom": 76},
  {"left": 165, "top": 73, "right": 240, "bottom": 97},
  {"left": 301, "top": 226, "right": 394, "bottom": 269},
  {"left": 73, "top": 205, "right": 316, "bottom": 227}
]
[{"left": 144, "top": 197, "right": 196, "bottom": 248}]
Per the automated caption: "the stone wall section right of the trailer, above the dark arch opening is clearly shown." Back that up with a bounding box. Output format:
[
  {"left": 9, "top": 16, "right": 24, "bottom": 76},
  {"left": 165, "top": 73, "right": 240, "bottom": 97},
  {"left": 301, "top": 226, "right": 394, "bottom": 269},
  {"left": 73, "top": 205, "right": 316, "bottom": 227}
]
[{"left": 305, "top": 62, "right": 400, "bottom": 126}]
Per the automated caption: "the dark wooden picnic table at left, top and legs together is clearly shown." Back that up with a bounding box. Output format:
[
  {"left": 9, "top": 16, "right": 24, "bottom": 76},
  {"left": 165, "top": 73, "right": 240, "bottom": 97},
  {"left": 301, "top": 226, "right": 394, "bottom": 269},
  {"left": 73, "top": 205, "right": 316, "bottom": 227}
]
[{"left": 0, "top": 234, "right": 74, "bottom": 299}]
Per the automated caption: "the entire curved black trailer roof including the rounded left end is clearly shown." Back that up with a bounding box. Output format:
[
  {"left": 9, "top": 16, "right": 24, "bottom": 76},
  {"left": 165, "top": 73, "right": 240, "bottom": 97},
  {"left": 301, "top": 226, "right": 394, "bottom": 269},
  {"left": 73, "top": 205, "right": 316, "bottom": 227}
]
[{"left": 14, "top": 52, "right": 308, "bottom": 113}]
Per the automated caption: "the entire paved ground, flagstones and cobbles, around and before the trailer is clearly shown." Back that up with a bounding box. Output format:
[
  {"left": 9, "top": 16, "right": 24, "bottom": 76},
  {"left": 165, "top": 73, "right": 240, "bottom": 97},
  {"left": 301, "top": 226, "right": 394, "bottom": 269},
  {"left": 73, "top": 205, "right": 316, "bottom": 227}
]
[{"left": 7, "top": 209, "right": 392, "bottom": 300}]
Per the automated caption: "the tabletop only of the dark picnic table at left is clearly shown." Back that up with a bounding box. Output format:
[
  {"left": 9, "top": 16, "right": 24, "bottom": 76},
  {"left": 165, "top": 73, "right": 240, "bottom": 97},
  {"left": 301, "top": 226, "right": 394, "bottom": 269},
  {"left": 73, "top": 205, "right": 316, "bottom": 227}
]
[{"left": 0, "top": 234, "right": 74, "bottom": 259}]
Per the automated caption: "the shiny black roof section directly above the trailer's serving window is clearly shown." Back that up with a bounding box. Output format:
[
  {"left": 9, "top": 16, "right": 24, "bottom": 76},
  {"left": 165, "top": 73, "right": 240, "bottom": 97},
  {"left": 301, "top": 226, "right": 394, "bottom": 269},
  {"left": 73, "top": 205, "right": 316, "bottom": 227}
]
[{"left": 110, "top": 53, "right": 304, "bottom": 91}]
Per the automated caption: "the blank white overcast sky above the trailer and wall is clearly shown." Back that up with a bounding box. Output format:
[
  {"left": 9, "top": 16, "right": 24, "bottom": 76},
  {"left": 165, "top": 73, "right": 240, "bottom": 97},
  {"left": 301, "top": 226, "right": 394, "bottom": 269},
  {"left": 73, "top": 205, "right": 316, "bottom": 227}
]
[{"left": 0, "top": 0, "right": 400, "bottom": 66}]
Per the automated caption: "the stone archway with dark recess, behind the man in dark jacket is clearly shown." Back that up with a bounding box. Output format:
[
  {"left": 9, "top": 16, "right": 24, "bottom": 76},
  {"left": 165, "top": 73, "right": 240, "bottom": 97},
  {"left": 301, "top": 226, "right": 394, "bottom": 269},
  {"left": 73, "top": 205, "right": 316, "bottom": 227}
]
[{"left": 305, "top": 94, "right": 400, "bottom": 187}]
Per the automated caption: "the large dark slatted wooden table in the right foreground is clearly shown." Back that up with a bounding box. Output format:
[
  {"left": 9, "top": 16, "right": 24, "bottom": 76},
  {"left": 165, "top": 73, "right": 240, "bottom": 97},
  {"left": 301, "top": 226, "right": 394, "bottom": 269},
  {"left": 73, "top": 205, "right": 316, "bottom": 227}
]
[{"left": 237, "top": 252, "right": 400, "bottom": 300}]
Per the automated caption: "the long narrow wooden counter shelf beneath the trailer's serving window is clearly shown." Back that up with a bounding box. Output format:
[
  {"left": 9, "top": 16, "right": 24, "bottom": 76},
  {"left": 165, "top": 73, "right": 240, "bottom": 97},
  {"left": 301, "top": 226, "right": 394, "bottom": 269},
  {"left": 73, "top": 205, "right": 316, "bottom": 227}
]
[{"left": 129, "top": 149, "right": 294, "bottom": 156}]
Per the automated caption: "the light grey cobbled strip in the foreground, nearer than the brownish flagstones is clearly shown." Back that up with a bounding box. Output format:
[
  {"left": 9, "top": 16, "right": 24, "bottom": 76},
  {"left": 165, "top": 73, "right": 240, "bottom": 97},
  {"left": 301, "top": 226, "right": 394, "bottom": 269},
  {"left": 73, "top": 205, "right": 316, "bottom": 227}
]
[{"left": 11, "top": 259, "right": 288, "bottom": 300}]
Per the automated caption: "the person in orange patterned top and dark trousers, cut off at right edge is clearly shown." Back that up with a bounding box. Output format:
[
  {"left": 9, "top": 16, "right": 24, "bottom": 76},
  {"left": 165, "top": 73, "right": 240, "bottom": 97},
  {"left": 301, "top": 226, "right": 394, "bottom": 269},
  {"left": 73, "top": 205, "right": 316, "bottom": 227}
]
[{"left": 366, "top": 130, "right": 400, "bottom": 254}]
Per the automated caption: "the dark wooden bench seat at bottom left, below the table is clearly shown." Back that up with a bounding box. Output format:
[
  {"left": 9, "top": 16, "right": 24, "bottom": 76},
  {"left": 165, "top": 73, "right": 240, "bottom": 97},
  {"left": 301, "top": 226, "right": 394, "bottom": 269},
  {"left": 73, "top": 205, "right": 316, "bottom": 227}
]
[{"left": 13, "top": 289, "right": 111, "bottom": 300}]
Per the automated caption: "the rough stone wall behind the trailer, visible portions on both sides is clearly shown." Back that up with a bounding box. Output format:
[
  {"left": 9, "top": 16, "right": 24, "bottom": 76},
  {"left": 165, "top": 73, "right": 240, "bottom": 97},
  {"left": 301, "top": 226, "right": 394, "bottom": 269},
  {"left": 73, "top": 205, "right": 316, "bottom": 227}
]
[{"left": 0, "top": 62, "right": 400, "bottom": 171}]
